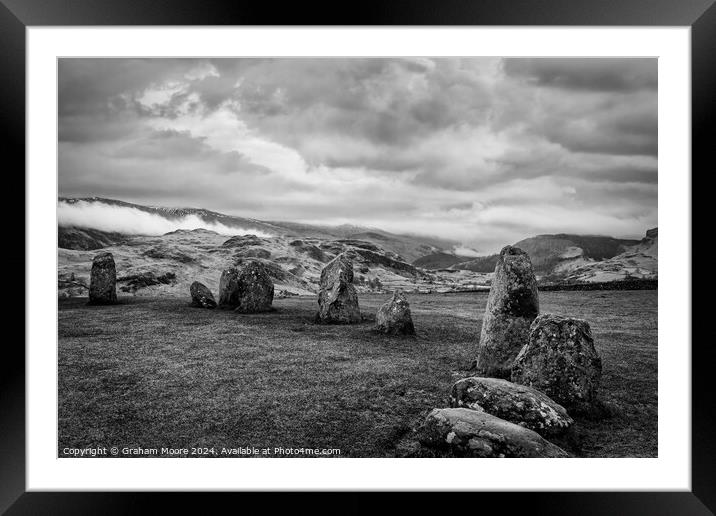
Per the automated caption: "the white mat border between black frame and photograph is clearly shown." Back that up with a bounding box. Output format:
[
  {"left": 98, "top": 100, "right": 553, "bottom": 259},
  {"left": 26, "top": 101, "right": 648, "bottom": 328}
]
[{"left": 26, "top": 27, "right": 691, "bottom": 491}]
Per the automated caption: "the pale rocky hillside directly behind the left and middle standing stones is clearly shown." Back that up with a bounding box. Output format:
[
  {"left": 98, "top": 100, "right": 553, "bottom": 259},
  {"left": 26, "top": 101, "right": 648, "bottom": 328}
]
[{"left": 58, "top": 228, "right": 489, "bottom": 297}]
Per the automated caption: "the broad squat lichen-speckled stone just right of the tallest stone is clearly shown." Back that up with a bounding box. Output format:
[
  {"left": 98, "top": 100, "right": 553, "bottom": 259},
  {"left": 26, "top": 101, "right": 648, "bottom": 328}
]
[{"left": 512, "top": 314, "right": 602, "bottom": 413}]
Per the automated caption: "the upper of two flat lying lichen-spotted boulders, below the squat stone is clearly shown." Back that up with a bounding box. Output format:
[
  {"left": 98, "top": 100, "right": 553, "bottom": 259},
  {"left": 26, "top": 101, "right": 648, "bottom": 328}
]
[{"left": 450, "top": 377, "right": 574, "bottom": 436}]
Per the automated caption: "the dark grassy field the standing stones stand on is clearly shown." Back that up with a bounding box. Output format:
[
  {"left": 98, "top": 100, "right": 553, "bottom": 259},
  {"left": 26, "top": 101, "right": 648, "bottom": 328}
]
[{"left": 58, "top": 290, "right": 657, "bottom": 457}]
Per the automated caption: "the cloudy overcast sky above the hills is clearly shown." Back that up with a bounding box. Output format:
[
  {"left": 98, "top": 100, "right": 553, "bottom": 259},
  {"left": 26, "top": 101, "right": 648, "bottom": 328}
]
[{"left": 59, "top": 58, "right": 657, "bottom": 253}]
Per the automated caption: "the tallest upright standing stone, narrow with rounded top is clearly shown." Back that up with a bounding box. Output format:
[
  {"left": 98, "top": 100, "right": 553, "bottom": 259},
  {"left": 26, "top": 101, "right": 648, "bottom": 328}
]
[{"left": 477, "top": 245, "right": 539, "bottom": 378}]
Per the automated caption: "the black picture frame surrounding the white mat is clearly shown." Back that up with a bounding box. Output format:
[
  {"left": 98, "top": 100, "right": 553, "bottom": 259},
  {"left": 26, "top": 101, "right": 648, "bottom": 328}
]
[{"left": 0, "top": 0, "right": 716, "bottom": 515}]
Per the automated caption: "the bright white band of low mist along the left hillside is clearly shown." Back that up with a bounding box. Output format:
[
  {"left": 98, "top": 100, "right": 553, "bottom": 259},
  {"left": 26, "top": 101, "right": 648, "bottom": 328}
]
[{"left": 57, "top": 201, "right": 272, "bottom": 237}]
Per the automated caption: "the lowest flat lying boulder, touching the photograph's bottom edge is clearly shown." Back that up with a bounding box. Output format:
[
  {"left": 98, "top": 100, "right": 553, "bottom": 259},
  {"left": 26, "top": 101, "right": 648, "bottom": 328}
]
[{"left": 418, "top": 408, "right": 569, "bottom": 458}]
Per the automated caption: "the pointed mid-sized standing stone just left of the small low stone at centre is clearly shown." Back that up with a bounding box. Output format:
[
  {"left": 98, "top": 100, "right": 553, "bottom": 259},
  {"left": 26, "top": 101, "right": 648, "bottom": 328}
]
[{"left": 316, "top": 253, "right": 361, "bottom": 324}]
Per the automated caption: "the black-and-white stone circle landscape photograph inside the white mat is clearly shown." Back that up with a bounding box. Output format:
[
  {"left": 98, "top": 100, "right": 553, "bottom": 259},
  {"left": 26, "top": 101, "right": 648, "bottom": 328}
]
[{"left": 58, "top": 56, "right": 656, "bottom": 464}]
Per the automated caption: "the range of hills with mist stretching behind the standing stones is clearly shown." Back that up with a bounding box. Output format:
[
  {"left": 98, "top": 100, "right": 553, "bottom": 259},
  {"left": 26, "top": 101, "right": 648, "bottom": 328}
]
[{"left": 58, "top": 197, "right": 658, "bottom": 297}]
